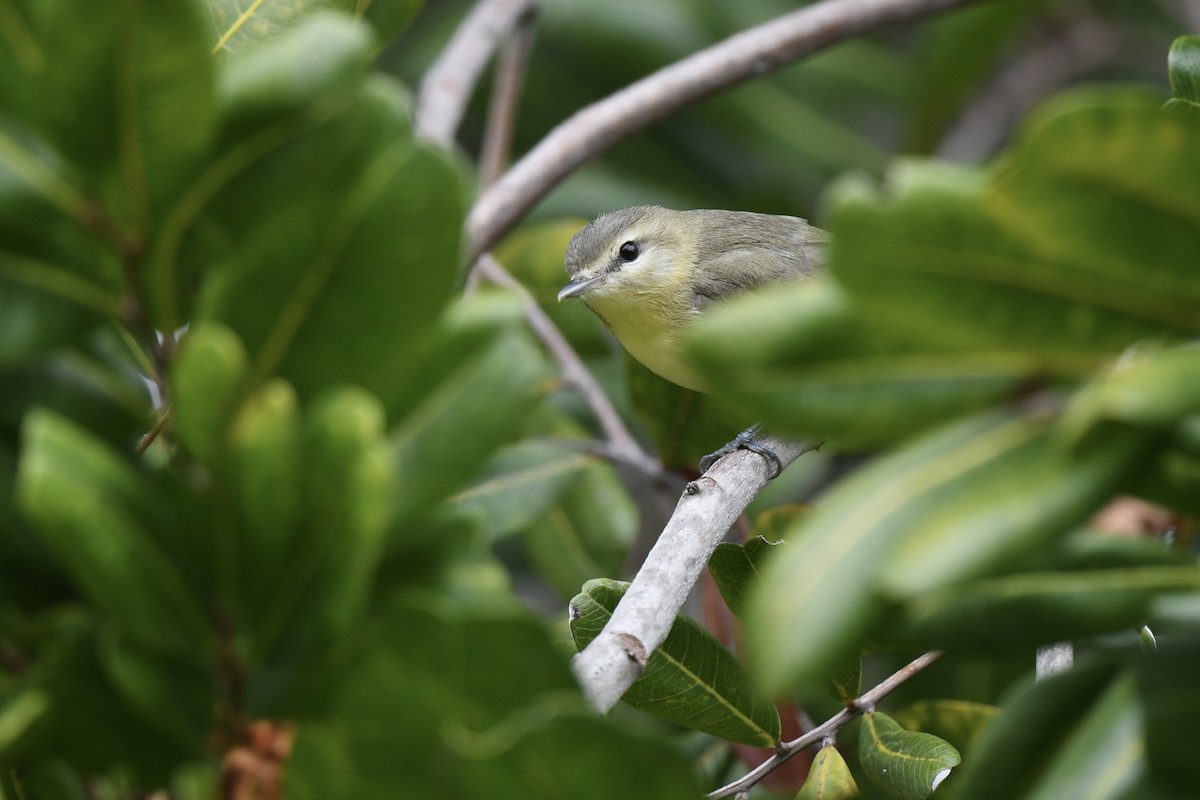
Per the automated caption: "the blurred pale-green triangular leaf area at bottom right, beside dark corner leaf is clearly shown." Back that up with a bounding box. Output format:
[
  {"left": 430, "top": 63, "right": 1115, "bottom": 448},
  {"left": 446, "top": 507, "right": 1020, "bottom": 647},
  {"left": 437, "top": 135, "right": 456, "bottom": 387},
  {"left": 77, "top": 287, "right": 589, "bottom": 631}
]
[{"left": 1026, "top": 674, "right": 1146, "bottom": 800}]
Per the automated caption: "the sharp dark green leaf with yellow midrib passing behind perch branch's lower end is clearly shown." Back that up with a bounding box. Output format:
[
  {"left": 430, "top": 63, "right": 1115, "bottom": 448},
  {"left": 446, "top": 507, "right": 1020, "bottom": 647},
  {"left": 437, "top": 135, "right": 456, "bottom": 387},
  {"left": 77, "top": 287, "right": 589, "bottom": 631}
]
[{"left": 571, "top": 578, "right": 780, "bottom": 747}]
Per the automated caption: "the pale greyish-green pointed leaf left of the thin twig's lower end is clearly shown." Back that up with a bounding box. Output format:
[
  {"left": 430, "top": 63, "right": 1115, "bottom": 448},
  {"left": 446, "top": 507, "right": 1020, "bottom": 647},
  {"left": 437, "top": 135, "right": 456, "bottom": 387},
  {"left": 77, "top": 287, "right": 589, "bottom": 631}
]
[{"left": 450, "top": 441, "right": 592, "bottom": 540}]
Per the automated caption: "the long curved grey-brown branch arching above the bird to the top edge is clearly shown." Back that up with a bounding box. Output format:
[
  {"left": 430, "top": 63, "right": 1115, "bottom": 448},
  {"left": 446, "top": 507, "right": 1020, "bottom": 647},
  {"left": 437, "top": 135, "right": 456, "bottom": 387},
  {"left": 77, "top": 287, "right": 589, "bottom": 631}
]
[{"left": 467, "top": 0, "right": 982, "bottom": 264}]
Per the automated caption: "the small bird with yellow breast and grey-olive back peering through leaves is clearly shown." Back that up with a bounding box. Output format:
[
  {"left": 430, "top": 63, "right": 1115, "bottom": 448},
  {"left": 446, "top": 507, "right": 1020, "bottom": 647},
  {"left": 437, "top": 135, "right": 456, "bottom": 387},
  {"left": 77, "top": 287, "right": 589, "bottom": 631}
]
[{"left": 558, "top": 205, "right": 828, "bottom": 391}]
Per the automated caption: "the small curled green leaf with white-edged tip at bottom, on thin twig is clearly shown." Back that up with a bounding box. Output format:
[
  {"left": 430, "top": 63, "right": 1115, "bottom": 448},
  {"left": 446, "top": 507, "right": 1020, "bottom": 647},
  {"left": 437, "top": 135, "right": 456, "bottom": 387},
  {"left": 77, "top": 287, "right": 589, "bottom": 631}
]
[{"left": 858, "top": 711, "right": 961, "bottom": 800}]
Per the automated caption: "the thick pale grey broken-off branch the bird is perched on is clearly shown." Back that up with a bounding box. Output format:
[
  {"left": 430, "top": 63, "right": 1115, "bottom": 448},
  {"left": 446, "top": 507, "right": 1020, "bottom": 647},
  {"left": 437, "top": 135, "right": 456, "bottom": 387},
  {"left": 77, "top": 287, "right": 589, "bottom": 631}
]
[{"left": 571, "top": 437, "right": 812, "bottom": 712}]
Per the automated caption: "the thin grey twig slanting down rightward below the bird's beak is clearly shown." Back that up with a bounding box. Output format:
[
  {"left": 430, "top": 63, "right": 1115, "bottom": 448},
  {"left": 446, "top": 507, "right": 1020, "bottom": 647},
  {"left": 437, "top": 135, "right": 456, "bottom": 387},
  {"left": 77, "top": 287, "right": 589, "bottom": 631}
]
[{"left": 479, "top": 253, "right": 662, "bottom": 475}]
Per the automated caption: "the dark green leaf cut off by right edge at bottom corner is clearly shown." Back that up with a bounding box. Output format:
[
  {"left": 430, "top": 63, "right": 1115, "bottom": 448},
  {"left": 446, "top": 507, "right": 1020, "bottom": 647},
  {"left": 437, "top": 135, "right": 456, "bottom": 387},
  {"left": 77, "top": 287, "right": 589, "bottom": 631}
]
[{"left": 1136, "top": 628, "right": 1200, "bottom": 796}]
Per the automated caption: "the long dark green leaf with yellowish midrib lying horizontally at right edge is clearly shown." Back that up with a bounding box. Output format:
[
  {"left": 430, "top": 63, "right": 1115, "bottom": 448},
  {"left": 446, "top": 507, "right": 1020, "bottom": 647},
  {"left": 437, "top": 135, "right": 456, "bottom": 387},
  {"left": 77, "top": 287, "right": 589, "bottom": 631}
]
[{"left": 882, "top": 566, "right": 1200, "bottom": 651}]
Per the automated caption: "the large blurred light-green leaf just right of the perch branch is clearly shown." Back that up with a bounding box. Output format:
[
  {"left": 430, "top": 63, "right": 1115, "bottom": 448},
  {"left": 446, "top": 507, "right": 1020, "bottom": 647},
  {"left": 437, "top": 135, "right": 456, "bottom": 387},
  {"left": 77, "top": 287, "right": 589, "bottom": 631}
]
[{"left": 748, "top": 411, "right": 1140, "bottom": 688}]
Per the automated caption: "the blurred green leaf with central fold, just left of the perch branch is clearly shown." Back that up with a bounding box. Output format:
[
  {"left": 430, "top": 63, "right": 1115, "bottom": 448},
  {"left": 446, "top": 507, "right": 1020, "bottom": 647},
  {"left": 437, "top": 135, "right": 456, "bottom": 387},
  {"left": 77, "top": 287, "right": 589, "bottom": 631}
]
[{"left": 522, "top": 462, "right": 638, "bottom": 599}]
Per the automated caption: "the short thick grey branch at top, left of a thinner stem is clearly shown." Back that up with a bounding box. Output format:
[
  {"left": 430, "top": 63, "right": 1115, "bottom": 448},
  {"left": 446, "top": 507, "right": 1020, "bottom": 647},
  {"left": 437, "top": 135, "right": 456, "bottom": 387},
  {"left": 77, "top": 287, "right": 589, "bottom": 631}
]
[{"left": 416, "top": 0, "right": 536, "bottom": 148}]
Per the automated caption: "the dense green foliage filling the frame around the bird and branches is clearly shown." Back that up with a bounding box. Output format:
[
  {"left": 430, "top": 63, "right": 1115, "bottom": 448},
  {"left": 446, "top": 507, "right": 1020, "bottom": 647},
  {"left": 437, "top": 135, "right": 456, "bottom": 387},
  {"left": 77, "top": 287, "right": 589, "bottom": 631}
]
[{"left": 0, "top": 0, "right": 1200, "bottom": 800}]
